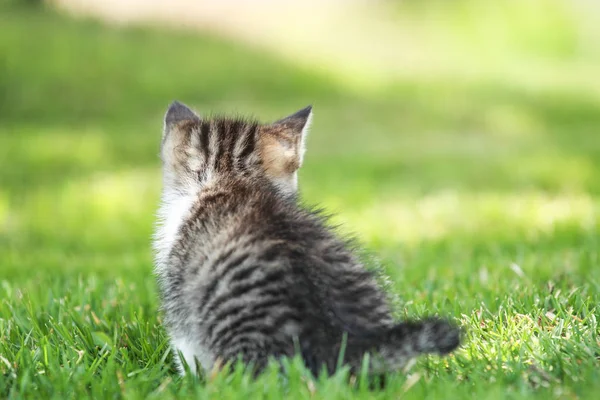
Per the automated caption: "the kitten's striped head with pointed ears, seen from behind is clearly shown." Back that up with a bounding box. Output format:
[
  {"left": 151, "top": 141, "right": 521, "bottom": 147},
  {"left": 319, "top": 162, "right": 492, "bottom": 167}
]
[{"left": 160, "top": 102, "right": 312, "bottom": 194}]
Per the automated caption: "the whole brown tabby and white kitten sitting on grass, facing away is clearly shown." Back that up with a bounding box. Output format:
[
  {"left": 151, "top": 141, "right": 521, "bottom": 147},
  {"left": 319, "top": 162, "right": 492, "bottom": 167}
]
[{"left": 155, "top": 102, "right": 459, "bottom": 373}]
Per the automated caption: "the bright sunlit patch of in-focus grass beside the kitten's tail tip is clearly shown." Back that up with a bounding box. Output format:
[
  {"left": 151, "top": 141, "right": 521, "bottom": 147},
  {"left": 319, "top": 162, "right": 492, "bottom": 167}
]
[{"left": 459, "top": 288, "right": 599, "bottom": 374}]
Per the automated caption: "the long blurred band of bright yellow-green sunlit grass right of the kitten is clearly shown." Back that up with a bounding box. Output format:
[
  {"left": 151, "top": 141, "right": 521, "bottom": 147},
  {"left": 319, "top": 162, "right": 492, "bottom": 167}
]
[{"left": 331, "top": 191, "right": 600, "bottom": 245}]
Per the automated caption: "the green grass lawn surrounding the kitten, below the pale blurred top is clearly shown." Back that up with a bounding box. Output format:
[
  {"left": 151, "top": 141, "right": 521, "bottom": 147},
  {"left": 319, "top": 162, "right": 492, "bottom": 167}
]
[{"left": 0, "top": 1, "right": 600, "bottom": 399}]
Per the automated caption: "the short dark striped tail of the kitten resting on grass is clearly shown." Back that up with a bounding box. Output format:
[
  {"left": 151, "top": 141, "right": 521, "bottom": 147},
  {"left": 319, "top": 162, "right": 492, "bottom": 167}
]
[{"left": 344, "top": 318, "right": 461, "bottom": 373}]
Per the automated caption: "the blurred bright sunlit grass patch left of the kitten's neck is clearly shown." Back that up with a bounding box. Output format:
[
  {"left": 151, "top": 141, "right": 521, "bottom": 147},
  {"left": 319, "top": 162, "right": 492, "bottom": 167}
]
[{"left": 1, "top": 169, "right": 161, "bottom": 242}]
